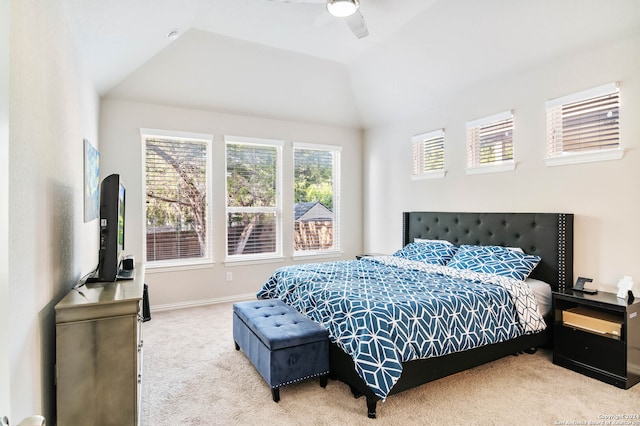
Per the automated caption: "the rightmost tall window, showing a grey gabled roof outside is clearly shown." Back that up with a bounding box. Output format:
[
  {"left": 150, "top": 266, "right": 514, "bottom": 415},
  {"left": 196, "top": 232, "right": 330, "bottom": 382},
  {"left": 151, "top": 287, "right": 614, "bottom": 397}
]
[{"left": 293, "top": 143, "right": 341, "bottom": 254}]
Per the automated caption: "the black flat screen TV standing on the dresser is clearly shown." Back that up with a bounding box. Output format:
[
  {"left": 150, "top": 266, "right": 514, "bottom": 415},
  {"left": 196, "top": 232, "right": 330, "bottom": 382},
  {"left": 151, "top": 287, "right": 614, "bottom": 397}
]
[{"left": 92, "top": 174, "right": 126, "bottom": 281}]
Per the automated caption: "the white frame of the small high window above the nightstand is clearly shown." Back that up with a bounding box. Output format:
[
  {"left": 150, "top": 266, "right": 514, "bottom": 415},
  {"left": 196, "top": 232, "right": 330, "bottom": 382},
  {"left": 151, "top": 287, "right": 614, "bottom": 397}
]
[{"left": 545, "top": 82, "right": 624, "bottom": 166}]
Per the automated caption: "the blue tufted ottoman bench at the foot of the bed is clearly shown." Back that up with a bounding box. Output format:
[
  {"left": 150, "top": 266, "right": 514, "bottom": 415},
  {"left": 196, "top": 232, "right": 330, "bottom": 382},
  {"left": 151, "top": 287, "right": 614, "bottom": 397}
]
[{"left": 233, "top": 299, "right": 329, "bottom": 402}]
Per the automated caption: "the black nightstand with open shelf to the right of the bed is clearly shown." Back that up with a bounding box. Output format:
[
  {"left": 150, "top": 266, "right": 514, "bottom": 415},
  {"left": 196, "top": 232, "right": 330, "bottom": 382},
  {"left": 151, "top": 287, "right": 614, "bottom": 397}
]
[{"left": 553, "top": 290, "right": 640, "bottom": 389}]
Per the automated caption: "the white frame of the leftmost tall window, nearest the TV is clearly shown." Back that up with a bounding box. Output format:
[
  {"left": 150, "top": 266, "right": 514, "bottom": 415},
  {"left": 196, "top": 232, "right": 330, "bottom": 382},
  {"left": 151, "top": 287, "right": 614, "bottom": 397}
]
[{"left": 140, "top": 128, "right": 214, "bottom": 270}]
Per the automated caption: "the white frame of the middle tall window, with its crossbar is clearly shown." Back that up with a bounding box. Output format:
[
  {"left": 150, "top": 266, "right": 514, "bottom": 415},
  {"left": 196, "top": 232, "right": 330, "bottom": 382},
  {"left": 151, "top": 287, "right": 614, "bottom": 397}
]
[{"left": 224, "top": 135, "right": 284, "bottom": 263}]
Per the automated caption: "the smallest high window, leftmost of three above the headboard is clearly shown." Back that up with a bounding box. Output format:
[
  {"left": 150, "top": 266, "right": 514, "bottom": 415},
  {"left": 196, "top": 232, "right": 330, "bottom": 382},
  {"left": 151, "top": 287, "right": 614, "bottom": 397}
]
[{"left": 411, "top": 129, "right": 444, "bottom": 180}]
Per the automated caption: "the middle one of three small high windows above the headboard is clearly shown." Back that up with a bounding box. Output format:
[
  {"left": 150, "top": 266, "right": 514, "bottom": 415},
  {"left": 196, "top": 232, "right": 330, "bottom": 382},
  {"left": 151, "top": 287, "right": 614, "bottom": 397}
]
[{"left": 467, "top": 111, "right": 515, "bottom": 173}]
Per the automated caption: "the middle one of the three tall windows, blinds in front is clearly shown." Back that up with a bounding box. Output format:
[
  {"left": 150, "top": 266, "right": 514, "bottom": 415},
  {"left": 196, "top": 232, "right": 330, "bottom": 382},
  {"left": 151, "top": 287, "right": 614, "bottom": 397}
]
[{"left": 225, "top": 136, "right": 282, "bottom": 260}]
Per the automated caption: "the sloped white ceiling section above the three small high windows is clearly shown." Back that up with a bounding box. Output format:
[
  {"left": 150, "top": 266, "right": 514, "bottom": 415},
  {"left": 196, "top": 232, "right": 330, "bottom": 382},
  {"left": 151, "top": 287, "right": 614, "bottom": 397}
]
[{"left": 349, "top": 0, "right": 640, "bottom": 128}]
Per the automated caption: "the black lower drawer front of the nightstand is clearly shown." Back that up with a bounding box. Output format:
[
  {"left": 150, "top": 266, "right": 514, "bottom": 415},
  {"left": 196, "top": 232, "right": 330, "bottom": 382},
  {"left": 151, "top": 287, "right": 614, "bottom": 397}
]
[{"left": 554, "top": 325, "right": 627, "bottom": 376}]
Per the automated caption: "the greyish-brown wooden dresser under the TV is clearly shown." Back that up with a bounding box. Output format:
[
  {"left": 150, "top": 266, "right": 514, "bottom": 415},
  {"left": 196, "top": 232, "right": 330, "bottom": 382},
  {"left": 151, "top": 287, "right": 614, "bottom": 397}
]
[{"left": 55, "top": 264, "right": 145, "bottom": 426}]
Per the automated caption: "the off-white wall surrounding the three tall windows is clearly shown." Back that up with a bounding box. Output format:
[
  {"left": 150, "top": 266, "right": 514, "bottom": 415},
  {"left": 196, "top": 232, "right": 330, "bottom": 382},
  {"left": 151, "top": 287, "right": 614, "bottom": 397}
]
[{"left": 100, "top": 98, "right": 362, "bottom": 309}]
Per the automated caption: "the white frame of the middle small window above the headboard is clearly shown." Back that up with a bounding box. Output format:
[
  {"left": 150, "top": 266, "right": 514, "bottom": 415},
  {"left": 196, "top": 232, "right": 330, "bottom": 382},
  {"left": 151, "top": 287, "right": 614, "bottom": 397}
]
[{"left": 465, "top": 110, "right": 516, "bottom": 175}]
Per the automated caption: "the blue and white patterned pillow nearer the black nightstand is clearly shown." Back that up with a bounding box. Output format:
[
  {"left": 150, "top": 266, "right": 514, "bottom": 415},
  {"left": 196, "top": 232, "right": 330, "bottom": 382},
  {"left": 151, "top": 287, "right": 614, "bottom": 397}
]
[{"left": 447, "top": 245, "right": 540, "bottom": 280}]
